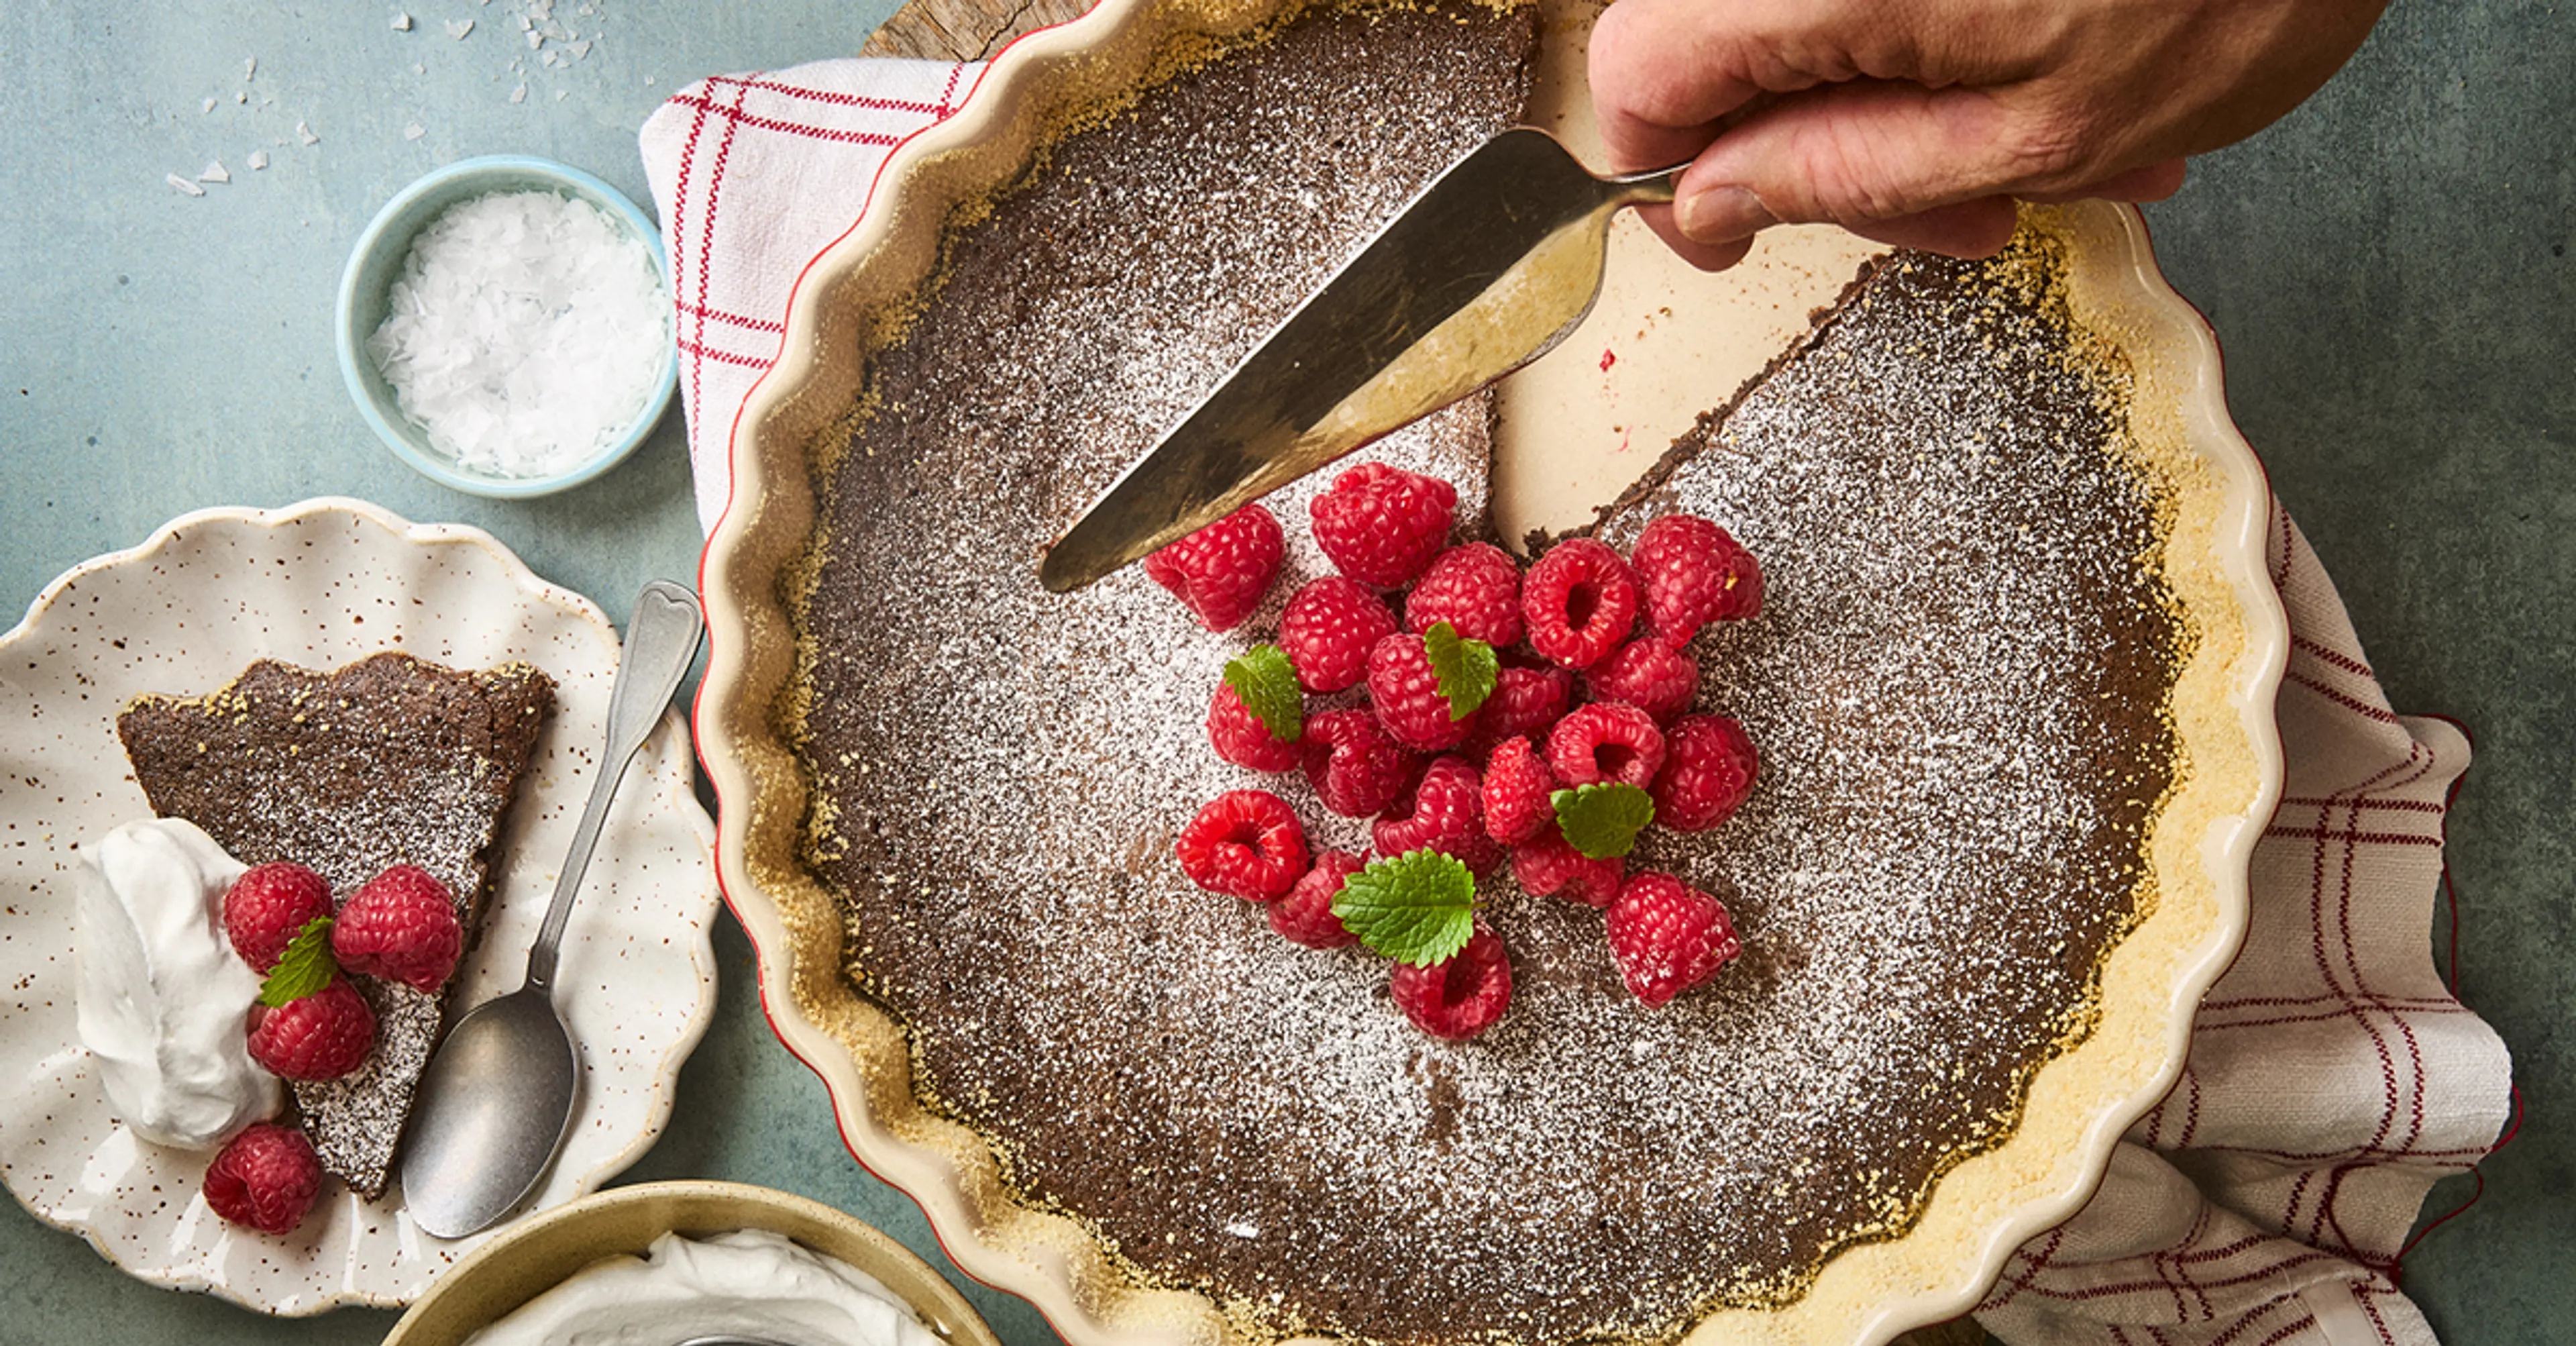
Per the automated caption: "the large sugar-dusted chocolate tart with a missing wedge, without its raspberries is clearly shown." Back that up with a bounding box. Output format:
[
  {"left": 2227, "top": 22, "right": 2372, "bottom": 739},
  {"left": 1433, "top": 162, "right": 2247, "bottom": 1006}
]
[{"left": 781, "top": 8, "right": 2184, "bottom": 1343}]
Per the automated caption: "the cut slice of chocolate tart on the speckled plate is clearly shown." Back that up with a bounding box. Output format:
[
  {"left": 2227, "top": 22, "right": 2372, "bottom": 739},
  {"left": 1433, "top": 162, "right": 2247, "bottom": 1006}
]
[{"left": 116, "top": 652, "right": 554, "bottom": 1196}]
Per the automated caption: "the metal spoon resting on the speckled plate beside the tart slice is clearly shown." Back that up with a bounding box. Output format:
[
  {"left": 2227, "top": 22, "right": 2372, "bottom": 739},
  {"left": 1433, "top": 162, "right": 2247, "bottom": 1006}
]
[{"left": 402, "top": 580, "right": 706, "bottom": 1238}]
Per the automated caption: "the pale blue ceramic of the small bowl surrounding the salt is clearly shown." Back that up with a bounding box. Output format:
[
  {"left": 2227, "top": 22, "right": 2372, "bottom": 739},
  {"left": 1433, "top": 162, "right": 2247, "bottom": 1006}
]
[{"left": 340, "top": 155, "right": 680, "bottom": 501}]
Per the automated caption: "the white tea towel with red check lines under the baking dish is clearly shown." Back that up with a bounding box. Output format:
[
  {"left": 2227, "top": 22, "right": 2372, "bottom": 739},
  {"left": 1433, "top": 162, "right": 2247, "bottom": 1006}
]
[{"left": 644, "top": 59, "right": 2509, "bottom": 1346}]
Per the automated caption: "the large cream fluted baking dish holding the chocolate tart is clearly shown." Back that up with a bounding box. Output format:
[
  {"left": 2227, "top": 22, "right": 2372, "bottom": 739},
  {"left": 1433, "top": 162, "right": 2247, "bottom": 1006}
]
[{"left": 698, "top": 0, "right": 2288, "bottom": 1346}]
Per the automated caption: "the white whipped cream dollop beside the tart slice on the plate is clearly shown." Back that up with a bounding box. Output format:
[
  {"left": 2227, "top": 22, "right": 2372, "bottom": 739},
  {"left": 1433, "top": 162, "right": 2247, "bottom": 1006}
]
[{"left": 74, "top": 817, "right": 281, "bottom": 1150}]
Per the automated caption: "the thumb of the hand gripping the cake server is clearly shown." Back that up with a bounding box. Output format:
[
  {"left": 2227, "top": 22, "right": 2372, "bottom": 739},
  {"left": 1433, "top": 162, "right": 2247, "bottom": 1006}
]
[{"left": 1674, "top": 80, "right": 2079, "bottom": 245}]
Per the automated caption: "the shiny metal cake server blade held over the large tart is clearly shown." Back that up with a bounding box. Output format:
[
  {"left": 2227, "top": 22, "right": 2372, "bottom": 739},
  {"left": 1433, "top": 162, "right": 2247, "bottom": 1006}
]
[{"left": 1038, "top": 126, "right": 1682, "bottom": 593}]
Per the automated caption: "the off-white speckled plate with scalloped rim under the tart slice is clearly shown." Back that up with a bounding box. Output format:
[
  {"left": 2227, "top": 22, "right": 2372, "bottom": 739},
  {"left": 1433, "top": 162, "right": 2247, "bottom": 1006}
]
[{"left": 0, "top": 501, "right": 716, "bottom": 1315}]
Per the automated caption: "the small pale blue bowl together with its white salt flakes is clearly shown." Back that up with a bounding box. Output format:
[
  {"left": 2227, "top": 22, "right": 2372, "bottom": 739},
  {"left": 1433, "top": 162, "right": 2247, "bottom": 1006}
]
[{"left": 337, "top": 155, "right": 680, "bottom": 498}]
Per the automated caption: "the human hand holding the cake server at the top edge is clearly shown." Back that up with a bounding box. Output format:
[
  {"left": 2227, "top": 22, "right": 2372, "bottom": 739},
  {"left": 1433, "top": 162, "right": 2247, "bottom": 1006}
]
[{"left": 1592, "top": 0, "right": 2385, "bottom": 271}]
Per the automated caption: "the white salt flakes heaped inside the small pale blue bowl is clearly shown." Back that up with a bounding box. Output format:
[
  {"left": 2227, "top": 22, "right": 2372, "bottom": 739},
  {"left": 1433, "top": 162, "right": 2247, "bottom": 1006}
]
[{"left": 366, "top": 191, "right": 669, "bottom": 477}]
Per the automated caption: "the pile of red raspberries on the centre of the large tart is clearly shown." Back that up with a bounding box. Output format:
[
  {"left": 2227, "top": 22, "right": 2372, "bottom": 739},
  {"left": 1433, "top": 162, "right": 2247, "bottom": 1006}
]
[{"left": 1144, "top": 464, "right": 1762, "bottom": 1039}]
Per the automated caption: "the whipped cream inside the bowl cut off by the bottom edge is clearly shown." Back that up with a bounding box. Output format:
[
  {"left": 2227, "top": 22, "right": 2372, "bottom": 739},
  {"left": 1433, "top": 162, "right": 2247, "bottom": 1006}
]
[{"left": 466, "top": 1230, "right": 943, "bottom": 1346}]
